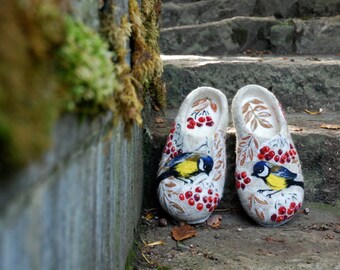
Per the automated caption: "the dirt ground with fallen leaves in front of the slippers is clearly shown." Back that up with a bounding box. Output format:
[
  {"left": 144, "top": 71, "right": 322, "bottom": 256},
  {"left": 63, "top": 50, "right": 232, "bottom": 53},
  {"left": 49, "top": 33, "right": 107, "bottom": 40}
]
[{"left": 136, "top": 203, "right": 340, "bottom": 270}]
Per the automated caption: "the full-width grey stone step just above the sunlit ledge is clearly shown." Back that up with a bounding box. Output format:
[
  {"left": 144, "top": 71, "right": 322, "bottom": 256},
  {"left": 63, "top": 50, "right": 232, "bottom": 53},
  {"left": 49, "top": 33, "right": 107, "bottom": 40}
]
[{"left": 160, "top": 16, "right": 340, "bottom": 55}]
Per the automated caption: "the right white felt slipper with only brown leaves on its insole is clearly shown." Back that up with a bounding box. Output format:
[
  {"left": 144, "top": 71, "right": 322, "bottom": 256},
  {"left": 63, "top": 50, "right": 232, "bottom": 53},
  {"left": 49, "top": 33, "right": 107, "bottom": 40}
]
[{"left": 232, "top": 85, "right": 304, "bottom": 226}]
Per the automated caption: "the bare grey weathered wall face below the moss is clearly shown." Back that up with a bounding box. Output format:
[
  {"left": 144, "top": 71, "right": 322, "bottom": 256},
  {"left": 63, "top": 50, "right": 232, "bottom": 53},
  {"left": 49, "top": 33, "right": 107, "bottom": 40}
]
[{"left": 0, "top": 115, "right": 143, "bottom": 269}]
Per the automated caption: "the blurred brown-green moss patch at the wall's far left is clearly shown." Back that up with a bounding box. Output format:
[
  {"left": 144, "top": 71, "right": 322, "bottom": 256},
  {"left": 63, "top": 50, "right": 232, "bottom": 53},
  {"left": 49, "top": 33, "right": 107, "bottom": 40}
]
[{"left": 0, "top": 0, "right": 64, "bottom": 175}]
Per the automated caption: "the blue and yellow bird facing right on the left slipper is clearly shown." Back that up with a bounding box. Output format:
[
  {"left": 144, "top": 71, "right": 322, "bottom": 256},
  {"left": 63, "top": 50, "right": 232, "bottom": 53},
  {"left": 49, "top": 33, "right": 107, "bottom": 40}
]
[{"left": 157, "top": 152, "right": 214, "bottom": 184}]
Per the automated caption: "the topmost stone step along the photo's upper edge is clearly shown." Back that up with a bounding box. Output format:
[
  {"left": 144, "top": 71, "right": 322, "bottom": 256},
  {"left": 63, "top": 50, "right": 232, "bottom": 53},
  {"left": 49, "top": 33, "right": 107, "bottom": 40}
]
[{"left": 161, "top": 0, "right": 340, "bottom": 27}]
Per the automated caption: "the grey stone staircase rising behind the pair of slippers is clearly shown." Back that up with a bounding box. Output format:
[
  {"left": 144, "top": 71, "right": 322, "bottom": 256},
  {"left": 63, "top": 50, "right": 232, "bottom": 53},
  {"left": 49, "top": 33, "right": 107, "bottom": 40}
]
[{"left": 140, "top": 0, "right": 340, "bottom": 269}]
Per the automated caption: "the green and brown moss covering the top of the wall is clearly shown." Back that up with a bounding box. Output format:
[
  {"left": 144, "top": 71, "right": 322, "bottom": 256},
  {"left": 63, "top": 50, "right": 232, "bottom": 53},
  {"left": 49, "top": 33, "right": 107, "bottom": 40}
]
[{"left": 0, "top": 0, "right": 165, "bottom": 175}]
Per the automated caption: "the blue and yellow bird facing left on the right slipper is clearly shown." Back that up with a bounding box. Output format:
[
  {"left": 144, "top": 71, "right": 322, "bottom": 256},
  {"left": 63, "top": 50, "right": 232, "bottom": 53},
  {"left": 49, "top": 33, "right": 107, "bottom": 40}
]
[{"left": 251, "top": 161, "right": 304, "bottom": 198}]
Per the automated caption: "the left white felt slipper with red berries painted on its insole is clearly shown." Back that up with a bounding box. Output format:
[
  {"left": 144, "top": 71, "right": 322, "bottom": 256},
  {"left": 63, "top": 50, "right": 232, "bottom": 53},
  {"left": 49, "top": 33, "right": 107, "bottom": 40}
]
[{"left": 158, "top": 87, "right": 228, "bottom": 224}]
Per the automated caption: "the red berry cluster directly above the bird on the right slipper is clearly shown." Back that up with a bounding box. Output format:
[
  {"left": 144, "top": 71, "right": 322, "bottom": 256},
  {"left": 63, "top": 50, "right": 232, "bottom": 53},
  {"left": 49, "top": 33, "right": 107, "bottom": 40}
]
[{"left": 257, "top": 144, "right": 297, "bottom": 164}]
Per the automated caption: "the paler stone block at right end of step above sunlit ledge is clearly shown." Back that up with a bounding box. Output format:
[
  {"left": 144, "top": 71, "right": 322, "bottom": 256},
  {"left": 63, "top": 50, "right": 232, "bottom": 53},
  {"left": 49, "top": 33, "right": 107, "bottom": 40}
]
[{"left": 294, "top": 16, "right": 340, "bottom": 54}]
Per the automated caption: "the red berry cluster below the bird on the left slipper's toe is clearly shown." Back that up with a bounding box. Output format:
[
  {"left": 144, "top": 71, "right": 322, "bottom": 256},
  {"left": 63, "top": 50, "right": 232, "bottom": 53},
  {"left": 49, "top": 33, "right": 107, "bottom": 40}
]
[{"left": 178, "top": 187, "right": 220, "bottom": 212}]
